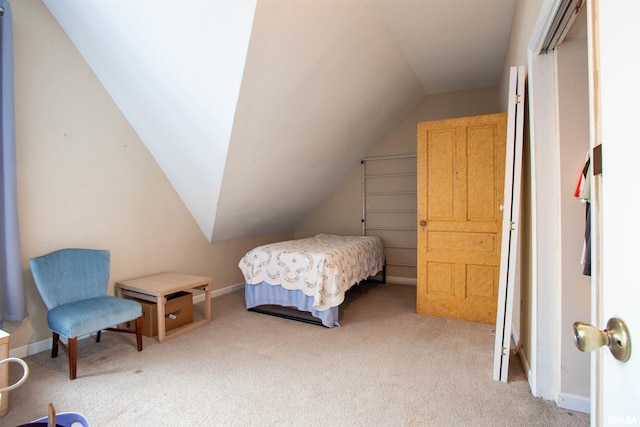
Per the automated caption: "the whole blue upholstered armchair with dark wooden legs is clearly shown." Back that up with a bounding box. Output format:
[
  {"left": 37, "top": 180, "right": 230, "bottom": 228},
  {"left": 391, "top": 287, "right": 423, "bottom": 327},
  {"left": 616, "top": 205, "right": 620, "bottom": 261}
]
[{"left": 29, "top": 249, "right": 142, "bottom": 380}]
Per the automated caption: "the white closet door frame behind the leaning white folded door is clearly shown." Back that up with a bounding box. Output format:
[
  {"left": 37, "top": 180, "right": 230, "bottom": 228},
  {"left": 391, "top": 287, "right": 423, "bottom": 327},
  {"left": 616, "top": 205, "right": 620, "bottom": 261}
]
[{"left": 527, "top": 0, "right": 562, "bottom": 401}]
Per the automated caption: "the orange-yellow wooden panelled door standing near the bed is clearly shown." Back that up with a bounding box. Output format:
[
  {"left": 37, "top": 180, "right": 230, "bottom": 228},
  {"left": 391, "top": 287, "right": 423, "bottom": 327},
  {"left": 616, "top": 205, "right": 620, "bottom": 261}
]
[{"left": 416, "top": 113, "right": 507, "bottom": 323}]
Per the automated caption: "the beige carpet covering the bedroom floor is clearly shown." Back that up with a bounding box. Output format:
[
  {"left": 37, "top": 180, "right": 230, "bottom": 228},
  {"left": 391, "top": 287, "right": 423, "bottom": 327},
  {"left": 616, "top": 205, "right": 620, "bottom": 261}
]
[{"left": 0, "top": 284, "right": 589, "bottom": 427}]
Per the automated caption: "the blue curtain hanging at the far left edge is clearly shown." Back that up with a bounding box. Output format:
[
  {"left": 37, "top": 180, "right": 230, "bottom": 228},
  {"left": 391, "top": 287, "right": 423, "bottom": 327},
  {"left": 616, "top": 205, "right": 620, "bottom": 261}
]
[{"left": 0, "top": 0, "right": 27, "bottom": 327}]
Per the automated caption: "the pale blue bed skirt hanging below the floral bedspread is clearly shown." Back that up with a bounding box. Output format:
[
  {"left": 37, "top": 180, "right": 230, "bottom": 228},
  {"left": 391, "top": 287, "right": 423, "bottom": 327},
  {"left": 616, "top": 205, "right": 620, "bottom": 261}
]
[{"left": 244, "top": 282, "right": 340, "bottom": 328}]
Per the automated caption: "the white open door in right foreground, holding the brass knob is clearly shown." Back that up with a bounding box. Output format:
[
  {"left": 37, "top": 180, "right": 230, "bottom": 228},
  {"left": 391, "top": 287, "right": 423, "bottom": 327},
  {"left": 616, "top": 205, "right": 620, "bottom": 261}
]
[{"left": 592, "top": 0, "right": 640, "bottom": 426}]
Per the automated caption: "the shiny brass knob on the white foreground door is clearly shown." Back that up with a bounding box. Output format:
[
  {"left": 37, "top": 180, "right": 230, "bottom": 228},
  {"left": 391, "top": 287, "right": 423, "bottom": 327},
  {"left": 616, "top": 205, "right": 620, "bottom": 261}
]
[{"left": 573, "top": 317, "right": 631, "bottom": 362}]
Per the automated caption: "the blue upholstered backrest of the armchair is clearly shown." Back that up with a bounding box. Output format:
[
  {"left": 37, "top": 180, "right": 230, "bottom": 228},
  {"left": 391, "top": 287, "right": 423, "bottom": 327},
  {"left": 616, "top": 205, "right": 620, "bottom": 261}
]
[{"left": 29, "top": 248, "right": 110, "bottom": 310}]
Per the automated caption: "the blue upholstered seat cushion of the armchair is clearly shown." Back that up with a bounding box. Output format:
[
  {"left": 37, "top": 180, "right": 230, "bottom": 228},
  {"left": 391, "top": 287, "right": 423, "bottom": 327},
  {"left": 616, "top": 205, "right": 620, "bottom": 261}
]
[{"left": 47, "top": 295, "right": 142, "bottom": 338}]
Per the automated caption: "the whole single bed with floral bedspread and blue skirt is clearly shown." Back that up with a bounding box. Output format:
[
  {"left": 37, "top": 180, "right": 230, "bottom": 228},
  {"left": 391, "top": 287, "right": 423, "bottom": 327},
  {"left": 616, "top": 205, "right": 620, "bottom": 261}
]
[{"left": 238, "top": 234, "right": 385, "bottom": 328}]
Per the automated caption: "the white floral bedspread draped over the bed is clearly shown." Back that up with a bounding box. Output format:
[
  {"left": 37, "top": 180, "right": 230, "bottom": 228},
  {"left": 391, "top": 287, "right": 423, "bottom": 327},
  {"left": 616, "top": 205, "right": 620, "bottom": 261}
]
[{"left": 238, "top": 234, "right": 384, "bottom": 311}]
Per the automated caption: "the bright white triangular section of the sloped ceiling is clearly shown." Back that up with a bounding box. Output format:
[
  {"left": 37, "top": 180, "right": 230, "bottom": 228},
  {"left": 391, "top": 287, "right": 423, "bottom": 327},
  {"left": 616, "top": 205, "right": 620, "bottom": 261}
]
[{"left": 44, "top": 0, "right": 255, "bottom": 239}]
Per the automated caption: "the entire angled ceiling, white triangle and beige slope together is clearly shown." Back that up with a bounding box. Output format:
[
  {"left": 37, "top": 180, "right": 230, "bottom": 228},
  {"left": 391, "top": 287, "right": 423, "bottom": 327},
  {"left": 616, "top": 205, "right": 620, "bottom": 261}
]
[{"left": 44, "top": 0, "right": 516, "bottom": 241}]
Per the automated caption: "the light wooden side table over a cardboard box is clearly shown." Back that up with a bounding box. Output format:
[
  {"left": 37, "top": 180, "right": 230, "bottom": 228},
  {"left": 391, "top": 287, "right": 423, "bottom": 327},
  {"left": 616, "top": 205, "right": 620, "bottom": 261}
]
[{"left": 115, "top": 273, "right": 211, "bottom": 342}]
